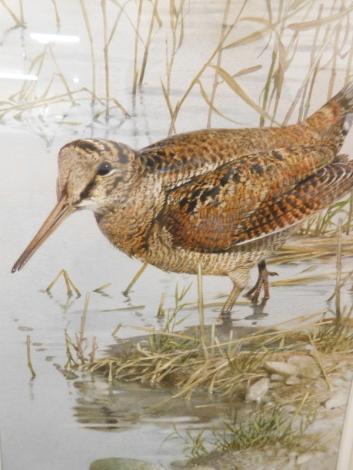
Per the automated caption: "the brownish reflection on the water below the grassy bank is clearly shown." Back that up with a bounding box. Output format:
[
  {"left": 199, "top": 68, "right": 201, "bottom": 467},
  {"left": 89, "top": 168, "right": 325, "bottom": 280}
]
[{"left": 73, "top": 378, "right": 245, "bottom": 432}]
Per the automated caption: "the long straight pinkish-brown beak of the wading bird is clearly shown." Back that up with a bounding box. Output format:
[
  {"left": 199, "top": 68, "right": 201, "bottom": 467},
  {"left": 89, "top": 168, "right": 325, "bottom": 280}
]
[{"left": 12, "top": 195, "right": 76, "bottom": 273}]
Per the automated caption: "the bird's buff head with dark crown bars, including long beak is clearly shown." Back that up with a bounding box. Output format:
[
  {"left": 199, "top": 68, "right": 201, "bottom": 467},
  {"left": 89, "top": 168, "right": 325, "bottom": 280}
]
[{"left": 12, "top": 139, "right": 138, "bottom": 272}]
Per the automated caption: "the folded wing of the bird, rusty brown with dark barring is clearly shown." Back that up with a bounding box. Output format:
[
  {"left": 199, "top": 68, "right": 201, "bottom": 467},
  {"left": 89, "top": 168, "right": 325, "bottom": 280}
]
[{"left": 158, "top": 147, "right": 353, "bottom": 252}]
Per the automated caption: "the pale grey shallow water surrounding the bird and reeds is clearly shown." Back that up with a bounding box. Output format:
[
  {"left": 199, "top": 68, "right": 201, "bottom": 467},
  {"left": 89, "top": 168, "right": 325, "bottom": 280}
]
[{"left": 0, "top": 0, "right": 352, "bottom": 470}]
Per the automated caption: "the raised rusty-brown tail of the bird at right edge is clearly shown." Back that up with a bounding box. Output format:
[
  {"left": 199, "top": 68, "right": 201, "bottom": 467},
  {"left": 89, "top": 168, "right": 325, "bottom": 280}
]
[{"left": 302, "top": 82, "right": 353, "bottom": 151}]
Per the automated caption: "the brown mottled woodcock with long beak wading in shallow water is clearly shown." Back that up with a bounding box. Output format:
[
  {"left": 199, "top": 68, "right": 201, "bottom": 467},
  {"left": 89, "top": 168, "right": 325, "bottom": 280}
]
[{"left": 12, "top": 82, "right": 353, "bottom": 318}]
